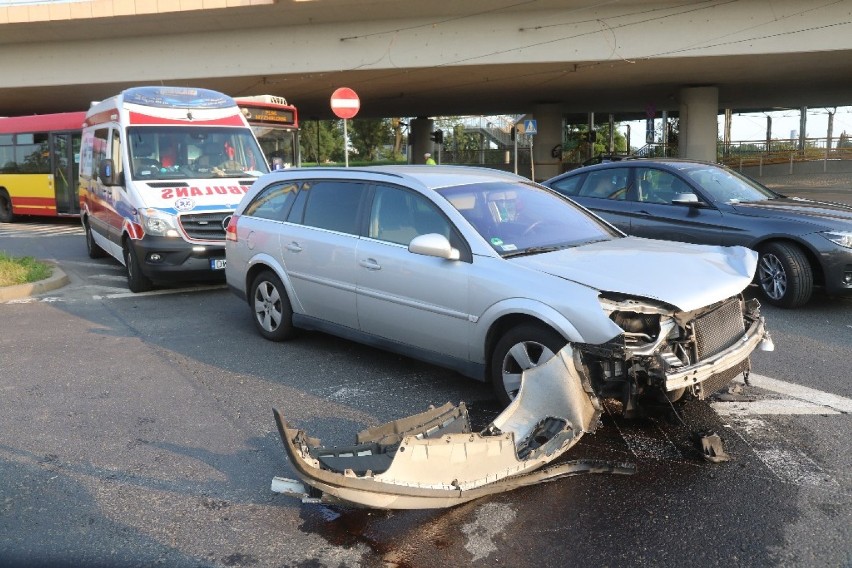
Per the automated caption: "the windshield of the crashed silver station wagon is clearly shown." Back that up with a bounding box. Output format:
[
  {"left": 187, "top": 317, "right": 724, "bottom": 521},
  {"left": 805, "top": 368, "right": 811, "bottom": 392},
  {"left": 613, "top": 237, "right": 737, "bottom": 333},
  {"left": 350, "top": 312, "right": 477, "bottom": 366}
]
[{"left": 438, "top": 182, "right": 618, "bottom": 256}]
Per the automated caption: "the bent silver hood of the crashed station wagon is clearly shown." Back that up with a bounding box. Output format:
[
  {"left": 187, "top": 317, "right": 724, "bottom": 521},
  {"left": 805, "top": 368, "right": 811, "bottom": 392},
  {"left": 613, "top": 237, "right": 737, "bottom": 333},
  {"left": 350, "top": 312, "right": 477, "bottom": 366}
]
[{"left": 509, "top": 237, "right": 757, "bottom": 311}]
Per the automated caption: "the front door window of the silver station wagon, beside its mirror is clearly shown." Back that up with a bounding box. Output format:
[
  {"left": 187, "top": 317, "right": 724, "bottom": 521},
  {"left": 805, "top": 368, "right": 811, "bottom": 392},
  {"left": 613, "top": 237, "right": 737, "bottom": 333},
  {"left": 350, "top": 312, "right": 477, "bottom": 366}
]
[{"left": 368, "top": 186, "right": 450, "bottom": 246}]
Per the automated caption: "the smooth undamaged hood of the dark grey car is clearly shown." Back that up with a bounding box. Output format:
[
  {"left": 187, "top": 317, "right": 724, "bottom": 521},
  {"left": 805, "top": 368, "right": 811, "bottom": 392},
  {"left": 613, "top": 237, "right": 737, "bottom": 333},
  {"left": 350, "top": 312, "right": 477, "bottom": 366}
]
[{"left": 731, "top": 197, "right": 852, "bottom": 230}]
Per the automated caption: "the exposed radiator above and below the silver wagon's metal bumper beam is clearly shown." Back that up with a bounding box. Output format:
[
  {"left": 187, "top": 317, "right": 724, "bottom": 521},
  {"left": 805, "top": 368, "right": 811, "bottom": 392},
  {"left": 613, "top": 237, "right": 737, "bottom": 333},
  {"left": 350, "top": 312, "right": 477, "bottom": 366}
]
[{"left": 693, "top": 299, "right": 751, "bottom": 399}]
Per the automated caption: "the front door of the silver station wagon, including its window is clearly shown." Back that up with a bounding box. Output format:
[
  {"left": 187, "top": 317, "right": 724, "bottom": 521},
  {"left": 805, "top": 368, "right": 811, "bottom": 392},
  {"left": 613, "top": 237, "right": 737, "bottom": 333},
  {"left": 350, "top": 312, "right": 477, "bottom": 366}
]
[{"left": 357, "top": 185, "right": 473, "bottom": 360}]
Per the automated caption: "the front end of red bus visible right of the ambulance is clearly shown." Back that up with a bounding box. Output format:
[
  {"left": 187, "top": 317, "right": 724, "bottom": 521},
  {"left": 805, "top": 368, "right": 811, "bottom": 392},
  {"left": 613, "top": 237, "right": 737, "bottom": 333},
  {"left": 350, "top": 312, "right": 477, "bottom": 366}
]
[{"left": 234, "top": 95, "right": 302, "bottom": 169}]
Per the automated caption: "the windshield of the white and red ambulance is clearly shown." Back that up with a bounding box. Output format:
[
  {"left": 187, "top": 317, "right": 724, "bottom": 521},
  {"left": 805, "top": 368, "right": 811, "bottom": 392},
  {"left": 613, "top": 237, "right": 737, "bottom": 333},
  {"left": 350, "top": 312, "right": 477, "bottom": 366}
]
[{"left": 127, "top": 126, "right": 269, "bottom": 180}]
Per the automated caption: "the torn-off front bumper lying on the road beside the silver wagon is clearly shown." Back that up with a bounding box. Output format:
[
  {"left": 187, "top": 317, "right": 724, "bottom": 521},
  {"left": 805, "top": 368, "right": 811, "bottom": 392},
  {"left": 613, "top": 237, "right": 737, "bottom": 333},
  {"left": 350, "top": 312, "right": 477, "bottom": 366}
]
[{"left": 272, "top": 345, "right": 633, "bottom": 509}]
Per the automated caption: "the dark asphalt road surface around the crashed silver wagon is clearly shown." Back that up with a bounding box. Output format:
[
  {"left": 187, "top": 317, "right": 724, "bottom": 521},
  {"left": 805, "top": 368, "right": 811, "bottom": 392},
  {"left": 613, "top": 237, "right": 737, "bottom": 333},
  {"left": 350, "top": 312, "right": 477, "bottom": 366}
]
[{"left": 0, "top": 214, "right": 852, "bottom": 568}]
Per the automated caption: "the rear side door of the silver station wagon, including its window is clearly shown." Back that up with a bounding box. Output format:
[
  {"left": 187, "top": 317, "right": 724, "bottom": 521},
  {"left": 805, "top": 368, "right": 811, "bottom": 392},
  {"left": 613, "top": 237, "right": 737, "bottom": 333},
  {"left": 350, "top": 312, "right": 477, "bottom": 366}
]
[{"left": 279, "top": 180, "right": 367, "bottom": 330}]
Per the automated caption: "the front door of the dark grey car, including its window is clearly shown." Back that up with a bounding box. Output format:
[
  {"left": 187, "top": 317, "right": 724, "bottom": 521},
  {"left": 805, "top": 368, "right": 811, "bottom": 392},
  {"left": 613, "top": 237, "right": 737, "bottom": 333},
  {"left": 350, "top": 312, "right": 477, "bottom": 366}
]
[{"left": 627, "top": 167, "right": 727, "bottom": 245}]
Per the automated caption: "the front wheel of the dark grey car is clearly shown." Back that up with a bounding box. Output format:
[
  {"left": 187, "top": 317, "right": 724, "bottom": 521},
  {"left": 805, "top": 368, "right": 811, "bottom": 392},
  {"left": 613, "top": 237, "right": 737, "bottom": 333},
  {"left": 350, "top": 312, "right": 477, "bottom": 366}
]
[{"left": 755, "top": 242, "right": 814, "bottom": 308}]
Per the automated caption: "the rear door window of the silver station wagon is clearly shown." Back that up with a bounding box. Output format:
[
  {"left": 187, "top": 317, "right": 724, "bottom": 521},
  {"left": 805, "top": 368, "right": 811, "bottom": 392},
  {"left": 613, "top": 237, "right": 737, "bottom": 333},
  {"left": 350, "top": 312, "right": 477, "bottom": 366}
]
[{"left": 302, "top": 180, "right": 366, "bottom": 235}]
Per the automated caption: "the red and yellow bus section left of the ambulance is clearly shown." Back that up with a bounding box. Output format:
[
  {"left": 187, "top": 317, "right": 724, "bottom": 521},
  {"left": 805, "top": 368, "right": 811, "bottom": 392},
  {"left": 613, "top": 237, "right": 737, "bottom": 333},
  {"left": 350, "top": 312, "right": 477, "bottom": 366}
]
[{"left": 0, "top": 112, "right": 86, "bottom": 223}]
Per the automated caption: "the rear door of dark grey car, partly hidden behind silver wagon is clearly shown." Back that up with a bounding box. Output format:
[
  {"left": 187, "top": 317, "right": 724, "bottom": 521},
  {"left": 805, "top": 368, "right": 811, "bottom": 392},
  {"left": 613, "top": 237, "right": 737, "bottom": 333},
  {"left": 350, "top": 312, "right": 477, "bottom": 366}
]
[{"left": 552, "top": 167, "right": 633, "bottom": 233}]
